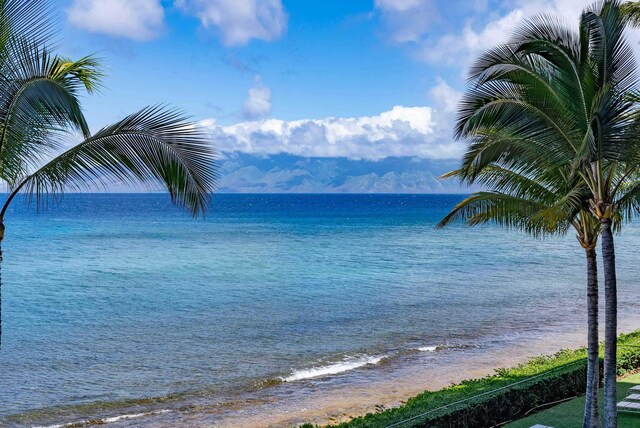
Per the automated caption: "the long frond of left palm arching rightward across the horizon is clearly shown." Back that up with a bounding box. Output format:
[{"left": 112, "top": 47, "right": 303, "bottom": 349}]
[{"left": 0, "top": 106, "right": 216, "bottom": 218}]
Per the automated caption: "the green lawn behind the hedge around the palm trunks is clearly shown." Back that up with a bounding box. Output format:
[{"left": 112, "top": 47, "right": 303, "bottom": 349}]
[{"left": 507, "top": 373, "right": 640, "bottom": 428}]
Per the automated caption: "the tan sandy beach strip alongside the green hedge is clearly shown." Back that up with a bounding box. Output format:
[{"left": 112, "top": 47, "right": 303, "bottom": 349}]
[{"left": 192, "top": 316, "right": 640, "bottom": 428}]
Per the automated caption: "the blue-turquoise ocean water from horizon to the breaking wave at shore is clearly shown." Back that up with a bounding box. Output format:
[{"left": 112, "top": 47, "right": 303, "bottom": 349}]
[{"left": 0, "top": 194, "right": 640, "bottom": 425}]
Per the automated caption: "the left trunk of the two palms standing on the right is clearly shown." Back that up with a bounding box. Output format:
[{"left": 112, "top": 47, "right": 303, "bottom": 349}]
[{"left": 582, "top": 248, "right": 600, "bottom": 428}]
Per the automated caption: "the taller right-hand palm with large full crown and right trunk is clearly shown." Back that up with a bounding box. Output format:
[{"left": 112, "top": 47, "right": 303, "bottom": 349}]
[{"left": 442, "top": 0, "right": 638, "bottom": 427}]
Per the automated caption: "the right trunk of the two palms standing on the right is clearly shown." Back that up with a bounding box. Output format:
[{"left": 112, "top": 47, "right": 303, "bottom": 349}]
[{"left": 601, "top": 219, "right": 618, "bottom": 428}]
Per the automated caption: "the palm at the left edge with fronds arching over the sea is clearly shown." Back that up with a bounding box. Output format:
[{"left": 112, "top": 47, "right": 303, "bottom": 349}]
[{"left": 0, "top": 0, "right": 215, "bottom": 346}]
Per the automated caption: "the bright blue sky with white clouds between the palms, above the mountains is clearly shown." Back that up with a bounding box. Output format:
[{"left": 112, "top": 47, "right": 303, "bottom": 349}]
[{"left": 54, "top": 0, "right": 624, "bottom": 191}]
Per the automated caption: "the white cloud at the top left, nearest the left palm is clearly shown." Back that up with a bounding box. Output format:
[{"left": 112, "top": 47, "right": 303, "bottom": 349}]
[{"left": 67, "top": 0, "right": 164, "bottom": 40}]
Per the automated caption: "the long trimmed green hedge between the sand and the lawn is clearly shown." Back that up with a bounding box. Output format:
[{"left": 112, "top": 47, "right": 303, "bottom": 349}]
[{"left": 318, "top": 330, "right": 640, "bottom": 428}]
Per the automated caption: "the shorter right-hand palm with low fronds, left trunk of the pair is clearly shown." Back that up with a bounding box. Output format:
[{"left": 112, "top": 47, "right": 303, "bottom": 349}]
[{"left": 437, "top": 169, "right": 600, "bottom": 427}]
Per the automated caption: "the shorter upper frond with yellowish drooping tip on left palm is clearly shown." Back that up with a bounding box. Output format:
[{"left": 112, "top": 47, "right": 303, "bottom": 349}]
[{"left": 0, "top": 42, "right": 102, "bottom": 186}]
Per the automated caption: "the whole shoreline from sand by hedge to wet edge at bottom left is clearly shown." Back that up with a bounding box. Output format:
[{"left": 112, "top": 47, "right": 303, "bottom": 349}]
[{"left": 12, "top": 315, "right": 640, "bottom": 428}]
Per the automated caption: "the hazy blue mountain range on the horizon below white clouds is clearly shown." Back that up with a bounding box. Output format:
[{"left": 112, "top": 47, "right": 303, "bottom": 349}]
[{"left": 218, "top": 152, "right": 469, "bottom": 193}]
